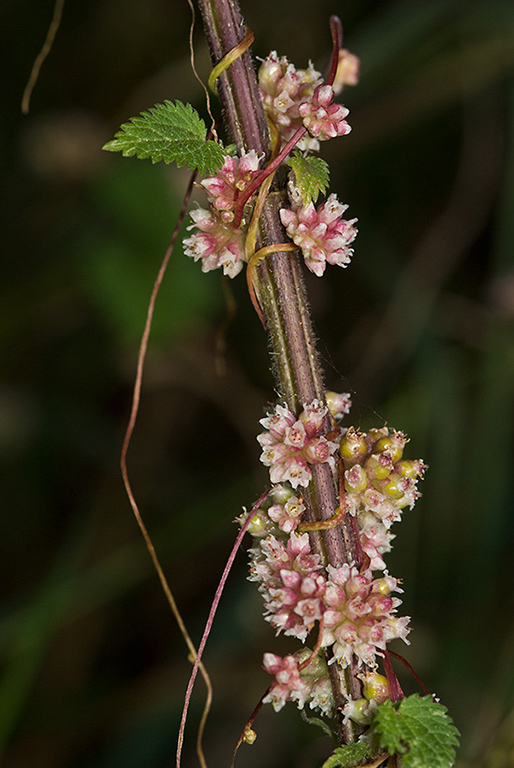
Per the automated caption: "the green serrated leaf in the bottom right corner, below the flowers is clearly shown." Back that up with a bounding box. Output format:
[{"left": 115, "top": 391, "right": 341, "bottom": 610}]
[{"left": 371, "top": 694, "right": 459, "bottom": 768}]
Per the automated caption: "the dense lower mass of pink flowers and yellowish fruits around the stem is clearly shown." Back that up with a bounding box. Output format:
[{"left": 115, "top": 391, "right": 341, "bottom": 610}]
[{"left": 241, "top": 392, "right": 425, "bottom": 723}]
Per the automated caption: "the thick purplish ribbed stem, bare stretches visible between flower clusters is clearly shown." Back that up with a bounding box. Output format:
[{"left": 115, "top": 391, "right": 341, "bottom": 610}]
[{"left": 194, "top": 0, "right": 358, "bottom": 743}]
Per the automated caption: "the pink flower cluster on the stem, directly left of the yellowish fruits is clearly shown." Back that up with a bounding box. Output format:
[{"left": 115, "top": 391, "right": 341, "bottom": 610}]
[{"left": 257, "top": 400, "right": 337, "bottom": 488}]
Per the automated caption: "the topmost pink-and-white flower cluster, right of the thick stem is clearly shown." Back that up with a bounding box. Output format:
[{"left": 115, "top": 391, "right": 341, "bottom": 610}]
[{"left": 258, "top": 51, "right": 351, "bottom": 150}]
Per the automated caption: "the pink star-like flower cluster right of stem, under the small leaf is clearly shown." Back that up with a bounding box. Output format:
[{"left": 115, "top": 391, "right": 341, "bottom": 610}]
[{"left": 280, "top": 194, "right": 357, "bottom": 277}]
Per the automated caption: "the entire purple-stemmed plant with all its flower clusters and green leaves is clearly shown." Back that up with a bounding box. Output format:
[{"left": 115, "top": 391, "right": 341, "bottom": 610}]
[{"left": 105, "top": 0, "right": 457, "bottom": 768}]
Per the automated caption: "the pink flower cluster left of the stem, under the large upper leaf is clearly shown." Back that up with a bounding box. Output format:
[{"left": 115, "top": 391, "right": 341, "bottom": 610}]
[{"left": 184, "top": 150, "right": 259, "bottom": 277}]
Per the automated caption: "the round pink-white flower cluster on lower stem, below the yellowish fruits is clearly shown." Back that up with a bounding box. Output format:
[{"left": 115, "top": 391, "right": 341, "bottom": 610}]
[{"left": 322, "top": 565, "right": 409, "bottom": 667}]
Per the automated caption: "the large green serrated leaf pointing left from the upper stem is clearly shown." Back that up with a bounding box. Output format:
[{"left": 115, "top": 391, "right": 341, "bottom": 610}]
[{"left": 103, "top": 101, "right": 225, "bottom": 175}]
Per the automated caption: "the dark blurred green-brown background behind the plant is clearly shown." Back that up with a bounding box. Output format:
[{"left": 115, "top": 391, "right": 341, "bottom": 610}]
[{"left": 0, "top": 0, "right": 514, "bottom": 768}]
